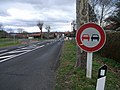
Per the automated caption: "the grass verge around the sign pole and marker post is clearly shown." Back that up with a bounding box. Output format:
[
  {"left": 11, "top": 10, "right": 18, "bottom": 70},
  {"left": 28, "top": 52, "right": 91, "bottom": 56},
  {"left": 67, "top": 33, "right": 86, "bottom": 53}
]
[{"left": 55, "top": 41, "right": 120, "bottom": 90}]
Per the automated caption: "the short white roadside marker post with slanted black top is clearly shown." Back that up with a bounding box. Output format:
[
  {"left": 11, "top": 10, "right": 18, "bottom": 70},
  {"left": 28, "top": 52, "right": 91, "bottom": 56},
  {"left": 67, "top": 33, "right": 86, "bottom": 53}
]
[{"left": 96, "top": 65, "right": 107, "bottom": 90}]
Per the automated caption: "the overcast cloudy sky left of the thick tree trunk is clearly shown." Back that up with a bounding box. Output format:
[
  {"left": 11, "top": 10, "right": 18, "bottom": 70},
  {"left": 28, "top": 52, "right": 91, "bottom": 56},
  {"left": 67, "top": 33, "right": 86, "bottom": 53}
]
[{"left": 0, "top": 0, "right": 76, "bottom": 32}]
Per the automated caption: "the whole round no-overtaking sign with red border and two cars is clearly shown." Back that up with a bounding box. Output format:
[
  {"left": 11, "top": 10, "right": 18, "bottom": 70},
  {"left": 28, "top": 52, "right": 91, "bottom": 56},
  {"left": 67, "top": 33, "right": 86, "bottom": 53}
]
[{"left": 76, "top": 23, "right": 106, "bottom": 52}]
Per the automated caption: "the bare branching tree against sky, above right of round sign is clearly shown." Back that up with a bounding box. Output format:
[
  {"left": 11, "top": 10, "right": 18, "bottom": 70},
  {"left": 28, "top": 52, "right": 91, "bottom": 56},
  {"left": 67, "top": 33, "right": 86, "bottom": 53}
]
[{"left": 90, "top": 0, "right": 117, "bottom": 26}]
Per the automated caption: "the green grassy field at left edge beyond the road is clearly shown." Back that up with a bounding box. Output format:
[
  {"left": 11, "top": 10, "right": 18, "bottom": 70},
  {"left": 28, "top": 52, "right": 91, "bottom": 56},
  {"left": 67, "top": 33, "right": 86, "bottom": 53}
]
[{"left": 0, "top": 38, "right": 20, "bottom": 48}]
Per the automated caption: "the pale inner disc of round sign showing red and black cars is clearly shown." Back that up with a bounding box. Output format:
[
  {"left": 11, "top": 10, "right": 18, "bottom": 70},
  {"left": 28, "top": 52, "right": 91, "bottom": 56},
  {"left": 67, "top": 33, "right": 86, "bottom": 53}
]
[{"left": 80, "top": 28, "right": 101, "bottom": 48}]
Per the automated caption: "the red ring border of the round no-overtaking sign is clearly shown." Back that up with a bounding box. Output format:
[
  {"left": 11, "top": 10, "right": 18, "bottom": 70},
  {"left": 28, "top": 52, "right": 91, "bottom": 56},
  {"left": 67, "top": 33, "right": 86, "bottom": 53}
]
[{"left": 76, "top": 23, "right": 106, "bottom": 52}]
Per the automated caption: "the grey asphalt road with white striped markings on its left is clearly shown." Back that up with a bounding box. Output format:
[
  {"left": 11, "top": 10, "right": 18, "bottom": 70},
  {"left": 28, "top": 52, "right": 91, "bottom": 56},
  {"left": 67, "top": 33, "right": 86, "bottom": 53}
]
[{"left": 0, "top": 40, "right": 63, "bottom": 90}]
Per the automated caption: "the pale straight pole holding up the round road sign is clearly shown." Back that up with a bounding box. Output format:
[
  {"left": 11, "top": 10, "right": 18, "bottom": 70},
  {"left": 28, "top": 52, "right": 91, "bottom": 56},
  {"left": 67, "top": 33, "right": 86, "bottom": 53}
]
[{"left": 86, "top": 52, "right": 93, "bottom": 79}]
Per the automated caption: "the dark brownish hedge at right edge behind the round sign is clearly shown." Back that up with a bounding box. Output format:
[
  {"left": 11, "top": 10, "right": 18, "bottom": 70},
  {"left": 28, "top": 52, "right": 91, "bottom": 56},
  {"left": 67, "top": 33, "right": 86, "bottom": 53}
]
[{"left": 99, "top": 32, "right": 120, "bottom": 62}]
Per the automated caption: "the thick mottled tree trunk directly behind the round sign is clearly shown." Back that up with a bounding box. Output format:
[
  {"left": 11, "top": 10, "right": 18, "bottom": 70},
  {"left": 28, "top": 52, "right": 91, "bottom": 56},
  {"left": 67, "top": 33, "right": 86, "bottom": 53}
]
[{"left": 75, "top": 0, "right": 89, "bottom": 68}]
